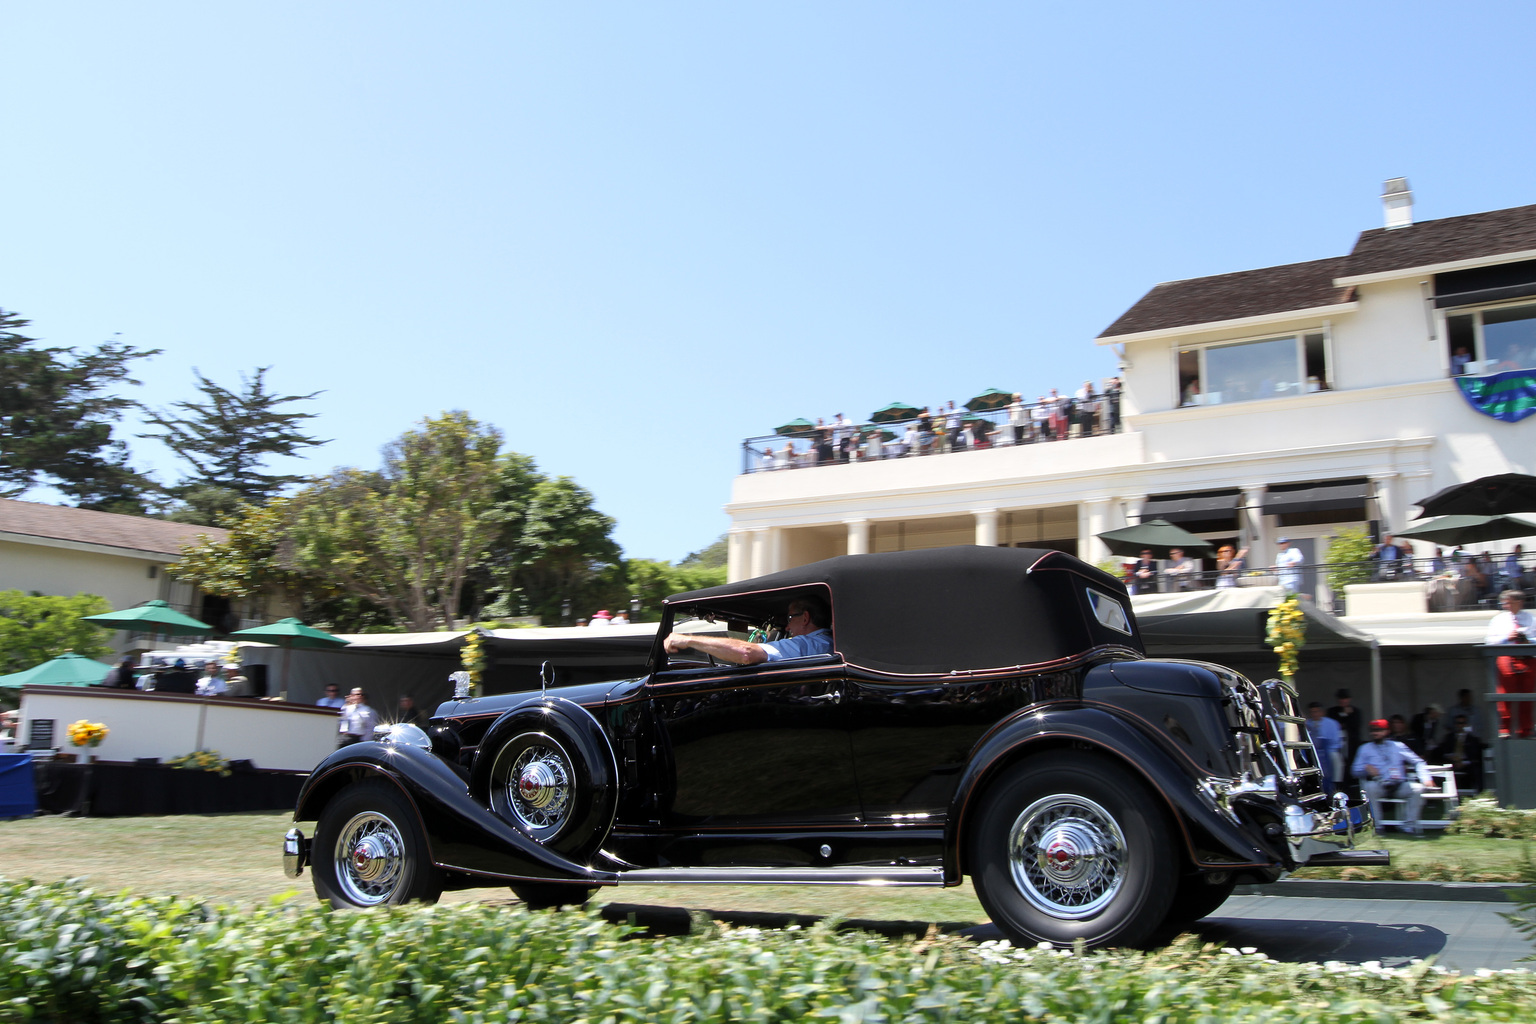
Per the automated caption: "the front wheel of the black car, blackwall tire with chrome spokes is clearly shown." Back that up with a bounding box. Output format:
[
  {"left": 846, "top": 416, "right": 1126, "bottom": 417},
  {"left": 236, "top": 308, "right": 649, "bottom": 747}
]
[{"left": 310, "top": 780, "right": 442, "bottom": 910}]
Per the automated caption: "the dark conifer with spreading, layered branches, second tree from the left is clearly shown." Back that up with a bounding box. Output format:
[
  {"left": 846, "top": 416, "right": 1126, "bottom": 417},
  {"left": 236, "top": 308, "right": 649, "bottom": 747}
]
[{"left": 140, "top": 367, "right": 330, "bottom": 502}]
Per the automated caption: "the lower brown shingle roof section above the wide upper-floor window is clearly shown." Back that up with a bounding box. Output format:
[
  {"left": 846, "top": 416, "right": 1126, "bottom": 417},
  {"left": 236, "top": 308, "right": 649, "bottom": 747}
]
[{"left": 1100, "top": 256, "right": 1350, "bottom": 338}]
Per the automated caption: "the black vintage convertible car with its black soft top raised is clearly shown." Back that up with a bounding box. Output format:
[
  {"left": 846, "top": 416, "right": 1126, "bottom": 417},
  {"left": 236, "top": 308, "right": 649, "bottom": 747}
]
[{"left": 284, "top": 547, "right": 1385, "bottom": 946}]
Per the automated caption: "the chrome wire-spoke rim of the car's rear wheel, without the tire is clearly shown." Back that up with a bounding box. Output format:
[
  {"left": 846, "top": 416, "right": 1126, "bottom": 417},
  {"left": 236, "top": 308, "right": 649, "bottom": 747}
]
[{"left": 1008, "top": 795, "right": 1126, "bottom": 918}]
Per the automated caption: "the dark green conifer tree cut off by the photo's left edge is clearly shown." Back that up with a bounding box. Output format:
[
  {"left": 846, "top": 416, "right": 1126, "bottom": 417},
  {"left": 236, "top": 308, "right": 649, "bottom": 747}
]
[{"left": 0, "top": 310, "right": 160, "bottom": 514}]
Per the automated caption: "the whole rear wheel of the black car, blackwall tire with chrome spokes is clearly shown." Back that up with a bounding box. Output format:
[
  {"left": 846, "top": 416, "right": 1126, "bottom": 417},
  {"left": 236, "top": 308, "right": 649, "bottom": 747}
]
[{"left": 969, "top": 751, "right": 1180, "bottom": 947}]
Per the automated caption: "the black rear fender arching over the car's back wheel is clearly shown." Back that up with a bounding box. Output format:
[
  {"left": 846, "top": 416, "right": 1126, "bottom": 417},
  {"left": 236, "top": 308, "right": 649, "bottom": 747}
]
[{"left": 945, "top": 703, "right": 1281, "bottom": 880}]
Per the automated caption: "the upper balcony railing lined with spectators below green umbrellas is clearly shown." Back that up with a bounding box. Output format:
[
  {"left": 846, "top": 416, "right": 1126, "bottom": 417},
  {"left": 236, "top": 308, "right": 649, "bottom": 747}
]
[{"left": 742, "top": 395, "right": 1121, "bottom": 473}]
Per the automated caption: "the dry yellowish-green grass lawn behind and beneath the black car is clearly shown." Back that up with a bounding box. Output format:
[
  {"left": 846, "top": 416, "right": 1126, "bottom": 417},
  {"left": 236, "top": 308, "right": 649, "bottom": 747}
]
[{"left": 0, "top": 812, "right": 1525, "bottom": 924}]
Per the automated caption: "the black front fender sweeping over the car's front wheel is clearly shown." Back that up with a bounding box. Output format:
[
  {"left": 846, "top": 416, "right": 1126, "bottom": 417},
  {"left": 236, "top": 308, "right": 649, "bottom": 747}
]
[{"left": 293, "top": 743, "right": 617, "bottom": 884}]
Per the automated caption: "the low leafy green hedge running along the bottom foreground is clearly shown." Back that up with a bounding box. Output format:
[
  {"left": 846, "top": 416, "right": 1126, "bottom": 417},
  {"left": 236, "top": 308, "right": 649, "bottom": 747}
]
[{"left": 0, "top": 883, "right": 1536, "bottom": 1024}]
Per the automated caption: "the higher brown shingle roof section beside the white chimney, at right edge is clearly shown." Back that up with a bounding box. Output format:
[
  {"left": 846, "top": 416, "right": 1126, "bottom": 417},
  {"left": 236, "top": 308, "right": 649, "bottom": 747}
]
[{"left": 1339, "top": 206, "right": 1536, "bottom": 278}]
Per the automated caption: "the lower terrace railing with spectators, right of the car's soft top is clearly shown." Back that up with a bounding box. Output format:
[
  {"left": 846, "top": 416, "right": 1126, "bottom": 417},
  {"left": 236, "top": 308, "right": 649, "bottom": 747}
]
[{"left": 1123, "top": 553, "right": 1536, "bottom": 611}]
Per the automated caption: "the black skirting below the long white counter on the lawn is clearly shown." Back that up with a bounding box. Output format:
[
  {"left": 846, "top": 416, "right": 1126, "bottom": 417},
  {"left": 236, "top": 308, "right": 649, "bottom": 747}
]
[{"left": 32, "top": 761, "right": 309, "bottom": 818}]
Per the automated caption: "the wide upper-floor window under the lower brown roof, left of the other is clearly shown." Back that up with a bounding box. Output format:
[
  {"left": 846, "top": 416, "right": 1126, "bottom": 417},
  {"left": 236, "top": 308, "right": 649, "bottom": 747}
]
[{"left": 1178, "top": 332, "right": 1329, "bottom": 405}]
